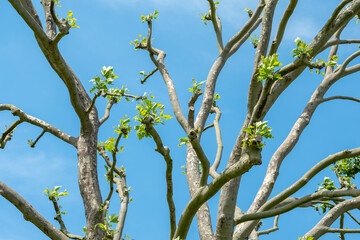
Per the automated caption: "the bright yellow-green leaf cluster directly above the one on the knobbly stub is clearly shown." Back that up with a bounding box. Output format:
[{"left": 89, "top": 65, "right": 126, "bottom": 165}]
[{"left": 257, "top": 53, "right": 282, "bottom": 82}]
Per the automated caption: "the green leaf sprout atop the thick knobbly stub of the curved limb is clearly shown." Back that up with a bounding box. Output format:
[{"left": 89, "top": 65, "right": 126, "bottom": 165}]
[{"left": 241, "top": 121, "right": 274, "bottom": 149}]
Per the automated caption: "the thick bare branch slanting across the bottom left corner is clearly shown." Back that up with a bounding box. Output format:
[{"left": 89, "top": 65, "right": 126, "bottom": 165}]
[{"left": 0, "top": 181, "right": 69, "bottom": 240}]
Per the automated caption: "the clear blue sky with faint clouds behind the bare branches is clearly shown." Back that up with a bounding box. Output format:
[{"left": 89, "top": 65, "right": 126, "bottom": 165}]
[{"left": 0, "top": 0, "right": 360, "bottom": 240}]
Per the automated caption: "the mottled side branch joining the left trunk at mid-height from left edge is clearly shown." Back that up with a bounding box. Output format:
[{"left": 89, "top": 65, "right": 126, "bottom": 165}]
[{"left": 0, "top": 104, "right": 77, "bottom": 148}]
